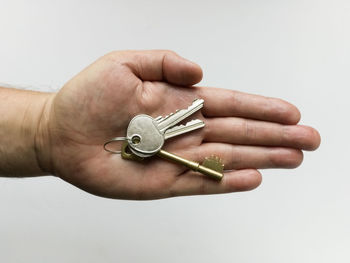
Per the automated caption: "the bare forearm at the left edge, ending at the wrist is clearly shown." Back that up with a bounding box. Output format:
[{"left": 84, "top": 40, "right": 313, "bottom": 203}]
[{"left": 0, "top": 87, "right": 51, "bottom": 177}]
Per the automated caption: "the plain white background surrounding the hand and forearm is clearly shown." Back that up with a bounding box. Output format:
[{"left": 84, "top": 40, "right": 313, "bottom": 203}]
[{"left": 0, "top": 0, "right": 350, "bottom": 263}]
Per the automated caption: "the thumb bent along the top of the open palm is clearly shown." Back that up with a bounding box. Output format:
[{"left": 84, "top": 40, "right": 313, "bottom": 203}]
[{"left": 117, "top": 50, "right": 203, "bottom": 86}]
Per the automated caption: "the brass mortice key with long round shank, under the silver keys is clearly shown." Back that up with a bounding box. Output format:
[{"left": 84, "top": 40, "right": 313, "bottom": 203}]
[{"left": 121, "top": 142, "right": 224, "bottom": 180}]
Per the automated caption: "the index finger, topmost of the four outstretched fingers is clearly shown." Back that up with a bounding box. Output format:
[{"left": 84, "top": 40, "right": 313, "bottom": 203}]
[{"left": 194, "top": 87, "right": 300, "bottom": 125}]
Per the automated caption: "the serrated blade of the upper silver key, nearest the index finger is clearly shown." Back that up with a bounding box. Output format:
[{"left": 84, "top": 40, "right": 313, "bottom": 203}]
[{"left": 158, "top": 99, "right": 204, "bottom": 133}]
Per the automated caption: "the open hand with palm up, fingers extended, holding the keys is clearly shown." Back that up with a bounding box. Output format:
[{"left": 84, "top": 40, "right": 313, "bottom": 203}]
[{"left": 40, "top": 51, "right": 320, "bottom": 199}]
